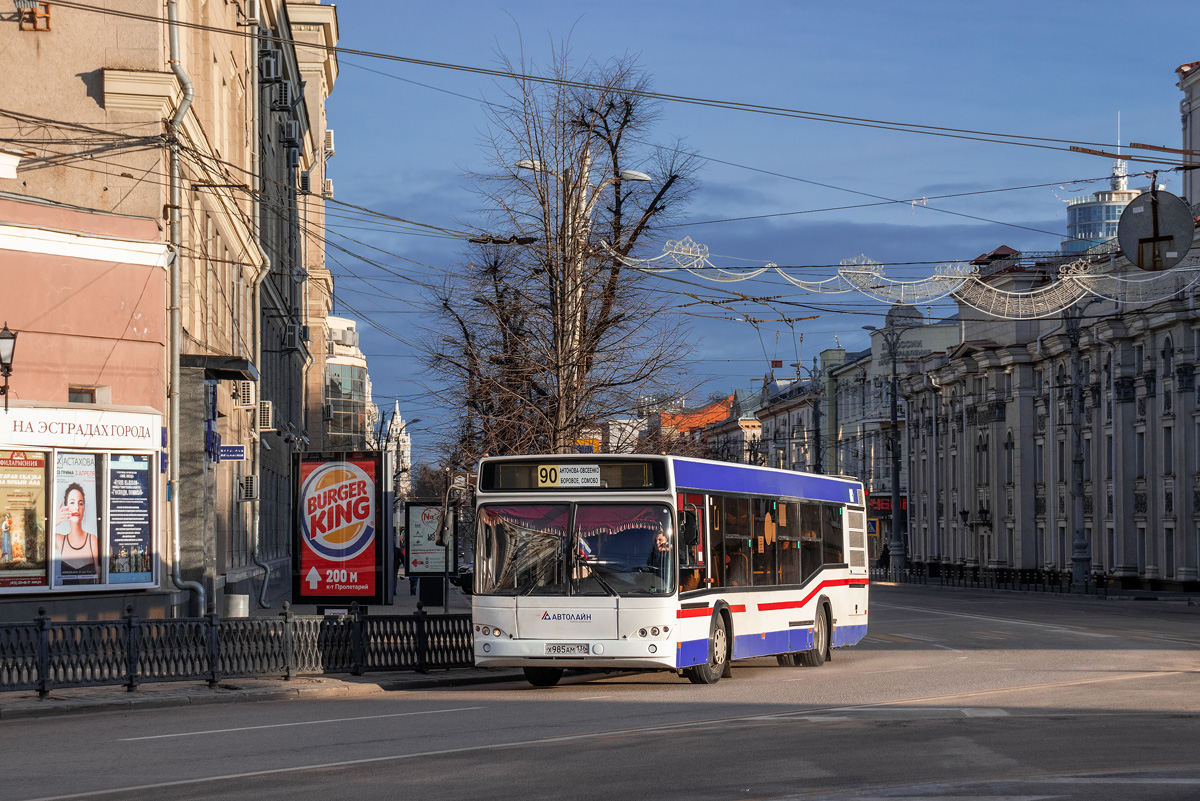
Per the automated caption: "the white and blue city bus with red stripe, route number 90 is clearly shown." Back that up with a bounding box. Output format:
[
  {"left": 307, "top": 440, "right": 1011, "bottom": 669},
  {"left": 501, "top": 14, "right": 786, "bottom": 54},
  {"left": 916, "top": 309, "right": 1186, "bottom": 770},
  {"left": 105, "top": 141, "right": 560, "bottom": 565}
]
[{"left": 473, "top": 454, "right": 869, "bottom": 686}]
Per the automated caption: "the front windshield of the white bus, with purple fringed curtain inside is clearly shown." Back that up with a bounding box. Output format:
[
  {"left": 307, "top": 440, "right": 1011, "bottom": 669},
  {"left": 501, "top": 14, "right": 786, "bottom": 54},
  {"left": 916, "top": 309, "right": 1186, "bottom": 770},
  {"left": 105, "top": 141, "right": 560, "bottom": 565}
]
[{"left": 475, "top": 504, "right": 676, "bottom": 596}]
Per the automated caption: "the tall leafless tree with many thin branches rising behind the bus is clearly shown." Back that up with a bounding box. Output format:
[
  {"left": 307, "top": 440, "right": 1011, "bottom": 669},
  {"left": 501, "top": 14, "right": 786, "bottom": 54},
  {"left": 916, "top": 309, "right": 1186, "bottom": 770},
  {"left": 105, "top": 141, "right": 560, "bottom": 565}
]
[{"left": 428, "top": 50, "right": 695, "bottom": 465}]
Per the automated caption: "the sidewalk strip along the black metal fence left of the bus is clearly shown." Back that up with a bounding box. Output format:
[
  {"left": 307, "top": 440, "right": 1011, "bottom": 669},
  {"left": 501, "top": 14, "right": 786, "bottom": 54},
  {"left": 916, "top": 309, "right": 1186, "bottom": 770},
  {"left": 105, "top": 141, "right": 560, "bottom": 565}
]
[{"left": 0, "top": 582, "right": 524, "bottom": 721}]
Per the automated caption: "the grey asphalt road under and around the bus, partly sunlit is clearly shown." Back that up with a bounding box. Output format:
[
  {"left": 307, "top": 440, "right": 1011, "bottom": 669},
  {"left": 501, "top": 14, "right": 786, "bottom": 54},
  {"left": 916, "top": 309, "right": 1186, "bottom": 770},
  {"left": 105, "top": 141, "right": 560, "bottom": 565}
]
[{"left": 0, "top": 586, "right": 1200, "bottom": 801}]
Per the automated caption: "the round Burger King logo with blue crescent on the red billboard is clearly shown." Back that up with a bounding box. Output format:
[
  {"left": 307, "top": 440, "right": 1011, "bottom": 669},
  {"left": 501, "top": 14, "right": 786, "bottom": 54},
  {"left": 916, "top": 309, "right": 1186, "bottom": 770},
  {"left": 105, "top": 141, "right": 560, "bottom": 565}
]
[{"left": 300, "top": 462, "right": 374, "bottom": 561}]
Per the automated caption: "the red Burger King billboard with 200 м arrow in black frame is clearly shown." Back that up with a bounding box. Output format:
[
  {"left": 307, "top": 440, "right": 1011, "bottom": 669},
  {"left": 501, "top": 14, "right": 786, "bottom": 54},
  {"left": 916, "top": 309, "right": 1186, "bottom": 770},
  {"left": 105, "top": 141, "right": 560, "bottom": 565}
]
[{"left": 292, "top": 453, "right": 388, "bottom": 603}]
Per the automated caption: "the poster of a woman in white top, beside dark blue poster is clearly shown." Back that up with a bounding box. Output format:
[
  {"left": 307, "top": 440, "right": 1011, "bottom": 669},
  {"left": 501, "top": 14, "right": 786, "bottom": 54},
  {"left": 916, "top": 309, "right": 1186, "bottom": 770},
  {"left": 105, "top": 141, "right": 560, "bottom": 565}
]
[{"left": 52, "top": 453, "right": 101, "bottom": 586}]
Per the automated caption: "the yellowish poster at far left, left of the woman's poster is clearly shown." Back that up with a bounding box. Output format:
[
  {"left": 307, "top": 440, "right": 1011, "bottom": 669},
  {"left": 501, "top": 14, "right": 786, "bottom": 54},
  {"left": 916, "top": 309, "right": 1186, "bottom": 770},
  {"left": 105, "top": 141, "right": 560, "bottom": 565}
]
[{"left": 0, "top": 451, "right": 48, "bottom": 592}]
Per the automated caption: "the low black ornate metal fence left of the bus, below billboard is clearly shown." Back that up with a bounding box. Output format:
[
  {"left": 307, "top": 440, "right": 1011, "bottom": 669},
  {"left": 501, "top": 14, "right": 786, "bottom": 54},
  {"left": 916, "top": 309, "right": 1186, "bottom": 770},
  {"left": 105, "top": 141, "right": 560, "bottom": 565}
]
[{"left": 0, "top": 604, "right": 474, "bottom": 698}]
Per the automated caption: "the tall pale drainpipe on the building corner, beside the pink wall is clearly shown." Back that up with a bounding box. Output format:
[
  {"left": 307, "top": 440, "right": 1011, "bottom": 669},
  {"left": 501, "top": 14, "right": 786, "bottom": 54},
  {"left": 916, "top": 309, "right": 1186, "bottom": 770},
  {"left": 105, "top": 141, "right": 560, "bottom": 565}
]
[{"left": 167, "top": 0, "right": 208, "bottom": 615}]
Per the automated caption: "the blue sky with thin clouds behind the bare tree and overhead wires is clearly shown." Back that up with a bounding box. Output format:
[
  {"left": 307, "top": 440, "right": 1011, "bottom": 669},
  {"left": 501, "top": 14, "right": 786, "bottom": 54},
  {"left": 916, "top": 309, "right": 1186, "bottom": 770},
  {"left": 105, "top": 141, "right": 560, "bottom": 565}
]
[{"left": 319, "top": 0, "right": 1200, "bottom": 457}]
